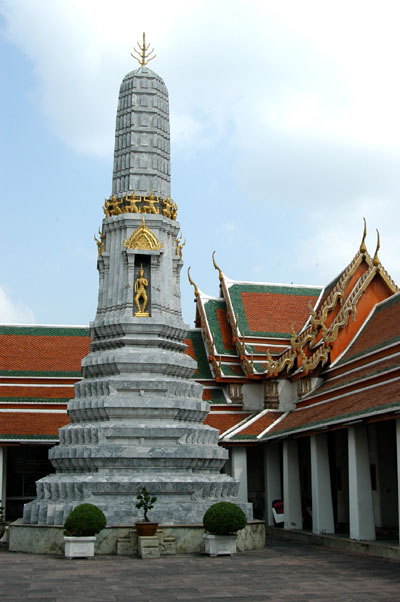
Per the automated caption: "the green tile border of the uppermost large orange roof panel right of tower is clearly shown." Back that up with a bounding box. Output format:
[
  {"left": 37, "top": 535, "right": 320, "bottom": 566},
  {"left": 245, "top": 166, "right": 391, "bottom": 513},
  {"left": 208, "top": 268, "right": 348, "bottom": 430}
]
[{"left": 228, "top": 284, "right": 323, "bottom": 339}]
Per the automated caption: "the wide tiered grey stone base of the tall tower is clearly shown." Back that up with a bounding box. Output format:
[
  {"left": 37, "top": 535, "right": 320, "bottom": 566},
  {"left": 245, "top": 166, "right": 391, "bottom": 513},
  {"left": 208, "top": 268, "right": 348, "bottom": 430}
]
[{"left": 24, "top": 318, "right": 252, "bottom": 526}]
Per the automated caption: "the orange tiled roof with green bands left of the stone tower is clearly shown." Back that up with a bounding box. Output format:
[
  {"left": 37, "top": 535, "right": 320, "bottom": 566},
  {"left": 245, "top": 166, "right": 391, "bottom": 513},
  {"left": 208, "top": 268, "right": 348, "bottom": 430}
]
[{"left": 0, "top": 325, "right": 90, "bottom": 443}]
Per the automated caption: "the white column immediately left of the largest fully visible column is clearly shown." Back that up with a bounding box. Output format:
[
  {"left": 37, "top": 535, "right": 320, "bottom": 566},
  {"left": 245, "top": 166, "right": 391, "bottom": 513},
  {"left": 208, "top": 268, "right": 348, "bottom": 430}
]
[{"left": 310, "top": 434, "right": 335, "bottom": 533}]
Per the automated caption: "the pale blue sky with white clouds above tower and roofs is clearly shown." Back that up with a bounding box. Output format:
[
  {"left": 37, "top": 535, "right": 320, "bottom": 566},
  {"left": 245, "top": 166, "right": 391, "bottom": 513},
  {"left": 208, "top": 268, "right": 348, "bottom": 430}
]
[{"left": 0, "top": 0, "right": 400, "bottom": 325}]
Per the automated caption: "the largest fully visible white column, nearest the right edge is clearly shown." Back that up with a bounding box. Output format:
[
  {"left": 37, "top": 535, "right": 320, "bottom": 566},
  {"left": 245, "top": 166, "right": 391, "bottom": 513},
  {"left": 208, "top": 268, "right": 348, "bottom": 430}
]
[{"left": 348, "top": 424, "right": 375, "bottom": 540}]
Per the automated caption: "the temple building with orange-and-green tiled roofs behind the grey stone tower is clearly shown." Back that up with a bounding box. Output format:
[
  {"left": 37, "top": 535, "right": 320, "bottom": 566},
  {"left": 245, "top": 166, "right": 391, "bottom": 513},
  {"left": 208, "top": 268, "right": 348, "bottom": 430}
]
[{"left": 0, "top": 223, "right": 400, "bottom": 540}]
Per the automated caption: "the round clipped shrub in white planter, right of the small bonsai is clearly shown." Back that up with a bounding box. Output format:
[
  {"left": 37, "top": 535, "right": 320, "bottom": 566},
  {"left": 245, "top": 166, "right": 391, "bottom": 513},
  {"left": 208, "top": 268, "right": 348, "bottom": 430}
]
[{"left": 203, "top": 502, "right": 247, "bottom": 556}]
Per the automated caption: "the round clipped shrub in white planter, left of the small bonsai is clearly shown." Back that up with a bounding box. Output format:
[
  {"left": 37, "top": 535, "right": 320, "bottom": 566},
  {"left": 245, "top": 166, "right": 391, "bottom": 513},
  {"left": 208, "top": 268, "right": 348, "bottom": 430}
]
[{"left": 64, "top": 504, "right": 107, "bottom": 558}]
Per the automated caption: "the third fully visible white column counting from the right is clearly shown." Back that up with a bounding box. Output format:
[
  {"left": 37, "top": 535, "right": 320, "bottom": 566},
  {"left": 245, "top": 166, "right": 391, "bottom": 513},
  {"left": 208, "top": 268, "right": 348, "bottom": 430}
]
[{"left": 283, "top": 439, "right": 303, "bottom": 529}]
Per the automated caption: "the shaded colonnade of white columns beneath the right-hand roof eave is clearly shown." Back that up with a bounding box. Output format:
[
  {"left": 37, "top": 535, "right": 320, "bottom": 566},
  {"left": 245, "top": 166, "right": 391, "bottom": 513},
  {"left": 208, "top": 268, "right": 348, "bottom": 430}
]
[{"left": 231, "top": 419, "right": 400, "bottom": 540}]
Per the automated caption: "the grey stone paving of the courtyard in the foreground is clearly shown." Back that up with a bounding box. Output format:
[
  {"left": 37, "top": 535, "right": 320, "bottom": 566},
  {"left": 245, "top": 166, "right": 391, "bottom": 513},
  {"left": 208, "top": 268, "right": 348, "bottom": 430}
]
[{"left": 0, "top": 537, "right": 400, "bottom": 602}]
